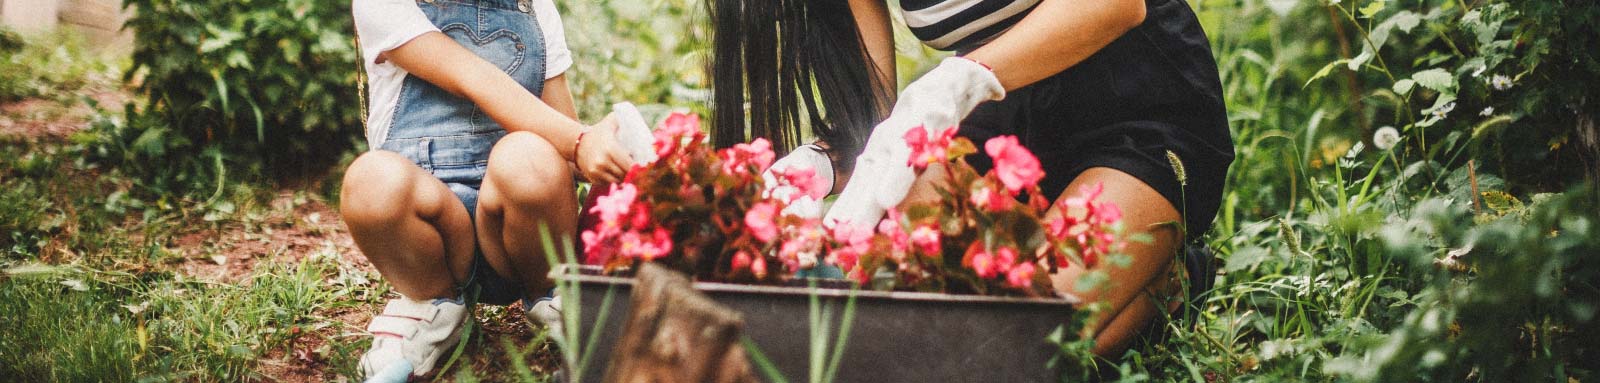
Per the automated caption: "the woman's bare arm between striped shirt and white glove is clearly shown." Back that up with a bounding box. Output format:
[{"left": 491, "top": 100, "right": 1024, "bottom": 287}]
[{"left": 966, "top": 0, "right": 1144, "bottom": 91}]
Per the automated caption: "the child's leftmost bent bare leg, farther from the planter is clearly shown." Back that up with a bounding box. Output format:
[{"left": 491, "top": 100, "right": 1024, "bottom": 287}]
[{"left": 339, "top": 151, "right": 474, "bottom": 300}]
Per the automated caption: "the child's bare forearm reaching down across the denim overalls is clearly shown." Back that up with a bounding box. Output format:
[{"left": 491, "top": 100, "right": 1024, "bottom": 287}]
[{"left": 384, "top": 32, "right": 584, "bottom": 160}]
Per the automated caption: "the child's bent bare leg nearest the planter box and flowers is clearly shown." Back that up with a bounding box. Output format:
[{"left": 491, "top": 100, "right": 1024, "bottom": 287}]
[{"left": 478, "top": 131, "right": 578, "bottom": 296}]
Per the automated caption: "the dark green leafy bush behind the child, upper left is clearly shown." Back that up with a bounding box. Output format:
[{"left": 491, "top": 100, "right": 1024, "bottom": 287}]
[{"left": 126, "top": 0, "right": 363, "bottom": 175}]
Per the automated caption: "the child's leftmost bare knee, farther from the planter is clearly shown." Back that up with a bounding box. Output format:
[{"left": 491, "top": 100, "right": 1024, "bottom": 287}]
[{"left": 339, "top": 151, "right": 418, "bottom": 226}]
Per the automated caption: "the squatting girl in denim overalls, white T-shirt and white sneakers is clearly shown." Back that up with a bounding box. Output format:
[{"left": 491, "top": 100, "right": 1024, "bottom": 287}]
[{"left": 339, "top": 0, "right": 648, "bottom": 380}]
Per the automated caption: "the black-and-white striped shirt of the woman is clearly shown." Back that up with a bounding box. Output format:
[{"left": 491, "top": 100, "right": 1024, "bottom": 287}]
[{"left": 901, "top": 0, "right": 1040, "bottom": 51}]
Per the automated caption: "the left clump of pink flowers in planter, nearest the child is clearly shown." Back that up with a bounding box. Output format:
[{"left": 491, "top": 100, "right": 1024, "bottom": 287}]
[{"left": 581, "top": 114, "right": 827, "bottom": 282}]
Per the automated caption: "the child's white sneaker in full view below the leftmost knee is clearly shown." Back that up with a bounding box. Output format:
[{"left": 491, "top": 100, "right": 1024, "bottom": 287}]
[{"left": 362, "top": 296, "right": 467, "bottom": 381}]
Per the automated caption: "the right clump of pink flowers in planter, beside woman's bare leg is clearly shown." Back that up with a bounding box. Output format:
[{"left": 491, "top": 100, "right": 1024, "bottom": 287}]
[{"left": 827, "top": 128, "right": 1123, "bottom": 296}]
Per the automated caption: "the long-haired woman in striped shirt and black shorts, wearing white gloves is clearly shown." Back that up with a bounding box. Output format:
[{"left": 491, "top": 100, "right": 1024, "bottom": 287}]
[{"left": 712, "top": 0, "right": 1234, "bottom": 356}]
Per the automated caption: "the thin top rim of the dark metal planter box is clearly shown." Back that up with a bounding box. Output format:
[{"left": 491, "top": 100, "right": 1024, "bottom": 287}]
[{"left": 550, "top": 264, "right": 1082, "bottom": 306}]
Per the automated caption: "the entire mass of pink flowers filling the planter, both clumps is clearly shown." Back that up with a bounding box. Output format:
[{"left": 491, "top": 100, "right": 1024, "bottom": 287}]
[{"left": 582, "top": 114, "right": 1123, "bottom": 296}]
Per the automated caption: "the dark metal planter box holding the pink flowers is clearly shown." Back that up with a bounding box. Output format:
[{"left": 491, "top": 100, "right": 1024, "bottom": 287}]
[{"left": 555, "top": 268, "right": 1077, "bottom": 381}]
